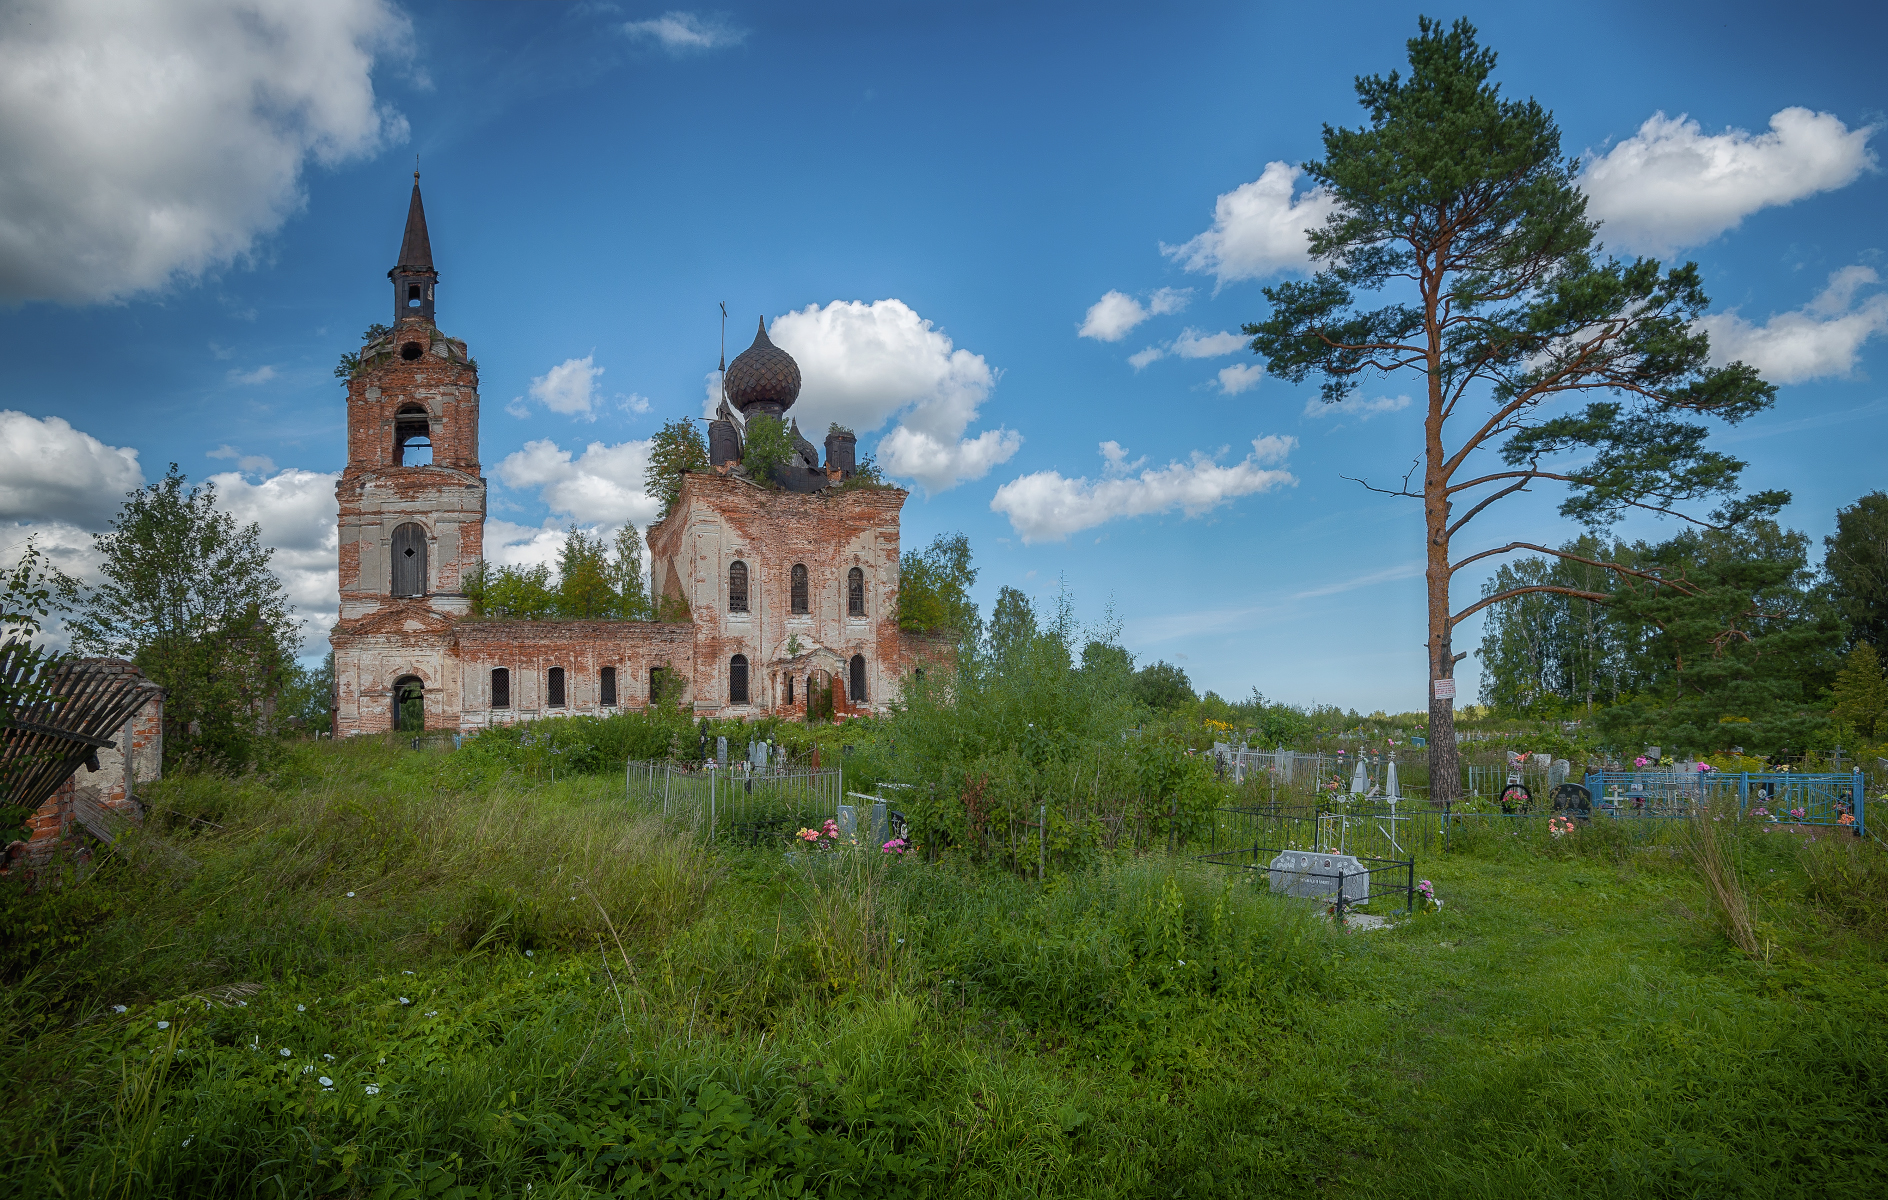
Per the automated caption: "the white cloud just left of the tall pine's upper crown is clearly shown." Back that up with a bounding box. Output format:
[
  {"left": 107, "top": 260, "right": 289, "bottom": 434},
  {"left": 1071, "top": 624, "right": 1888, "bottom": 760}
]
[{"left": 1161, "top": 162, "right": 1337, "bottom": 287}]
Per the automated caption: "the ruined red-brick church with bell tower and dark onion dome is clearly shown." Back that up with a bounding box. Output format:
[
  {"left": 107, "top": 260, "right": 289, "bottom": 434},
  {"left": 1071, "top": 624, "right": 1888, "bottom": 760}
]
[{"left": 332, "top": 182, "right": 921, "bottom": 738}]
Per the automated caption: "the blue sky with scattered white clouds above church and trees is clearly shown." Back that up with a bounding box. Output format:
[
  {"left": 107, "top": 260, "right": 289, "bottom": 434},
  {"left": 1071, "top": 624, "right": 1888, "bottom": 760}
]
[{"left": 0, "top": 0, "right": 1888, "bottom": 711}]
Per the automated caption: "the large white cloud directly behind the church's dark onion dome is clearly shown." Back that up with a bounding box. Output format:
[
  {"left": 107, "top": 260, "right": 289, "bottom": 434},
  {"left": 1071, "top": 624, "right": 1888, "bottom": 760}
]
[{"left": 766, "top": 300, "right": 1023, "bottom": 492}]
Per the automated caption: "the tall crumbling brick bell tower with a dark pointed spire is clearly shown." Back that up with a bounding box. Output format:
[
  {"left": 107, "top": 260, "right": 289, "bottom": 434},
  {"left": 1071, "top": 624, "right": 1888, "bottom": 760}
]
[{"left": 332, "top": 172, "right": 485, "bottom": 736}]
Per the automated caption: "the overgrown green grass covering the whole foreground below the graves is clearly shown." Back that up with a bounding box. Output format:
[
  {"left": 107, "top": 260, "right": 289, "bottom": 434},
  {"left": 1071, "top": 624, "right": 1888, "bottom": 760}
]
[{"left": 0, "top": 743, "right": 1888, "bottom": 1198}]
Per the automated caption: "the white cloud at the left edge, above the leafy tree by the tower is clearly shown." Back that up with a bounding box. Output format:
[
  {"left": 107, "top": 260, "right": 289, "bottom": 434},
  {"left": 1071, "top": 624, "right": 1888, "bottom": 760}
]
[{"left": 0, "top": 409, "right": 143, "bottom": 530}]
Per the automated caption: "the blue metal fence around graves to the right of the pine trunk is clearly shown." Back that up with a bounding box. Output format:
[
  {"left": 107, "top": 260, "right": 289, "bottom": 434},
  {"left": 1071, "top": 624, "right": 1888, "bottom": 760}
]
[{"left": 1586, "top": 772, "right": 1867, "bottom": 836}]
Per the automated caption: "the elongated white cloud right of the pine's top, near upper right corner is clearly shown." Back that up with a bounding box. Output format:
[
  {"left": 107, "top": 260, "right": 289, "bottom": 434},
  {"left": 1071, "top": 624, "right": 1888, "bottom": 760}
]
[{"left": 1580, "top": 108, "right": 1877, "bottom": 255}]
